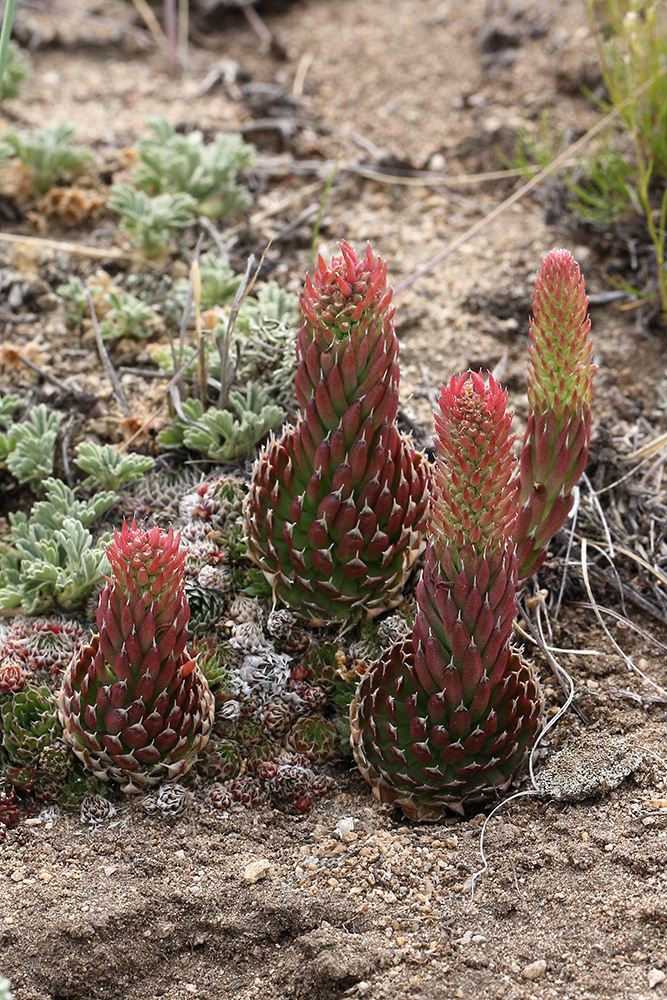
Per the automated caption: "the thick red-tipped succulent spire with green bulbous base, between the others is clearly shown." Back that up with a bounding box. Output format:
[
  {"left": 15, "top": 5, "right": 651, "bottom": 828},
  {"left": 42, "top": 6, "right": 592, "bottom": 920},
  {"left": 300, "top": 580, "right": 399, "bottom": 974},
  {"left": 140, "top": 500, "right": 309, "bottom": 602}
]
[{"left": 246, "top": 242, "right": 428, "bottom": 622}]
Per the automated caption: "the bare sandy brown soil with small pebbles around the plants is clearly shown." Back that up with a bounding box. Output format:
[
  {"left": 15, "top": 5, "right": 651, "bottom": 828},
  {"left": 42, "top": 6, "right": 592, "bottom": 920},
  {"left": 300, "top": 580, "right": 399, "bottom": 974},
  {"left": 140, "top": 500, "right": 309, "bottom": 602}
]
[{"left": 0, "top": 0, "right": 667, "bottom": 1000}]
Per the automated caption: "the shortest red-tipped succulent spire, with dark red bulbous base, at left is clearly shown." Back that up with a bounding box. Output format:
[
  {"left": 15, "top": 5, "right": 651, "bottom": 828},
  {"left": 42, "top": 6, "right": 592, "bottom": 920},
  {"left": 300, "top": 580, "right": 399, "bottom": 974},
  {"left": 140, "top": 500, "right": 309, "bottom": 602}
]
[{"left": 58, "top": 522, "right": 215, "bottom": 792}]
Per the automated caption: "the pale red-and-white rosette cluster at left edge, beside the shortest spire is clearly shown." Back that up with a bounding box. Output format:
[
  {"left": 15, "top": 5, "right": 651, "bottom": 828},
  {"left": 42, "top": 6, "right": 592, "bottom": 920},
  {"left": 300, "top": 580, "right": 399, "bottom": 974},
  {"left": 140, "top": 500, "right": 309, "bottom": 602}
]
[{"left": 0, "top": 617, "right": 86, "bottom": 692}]
